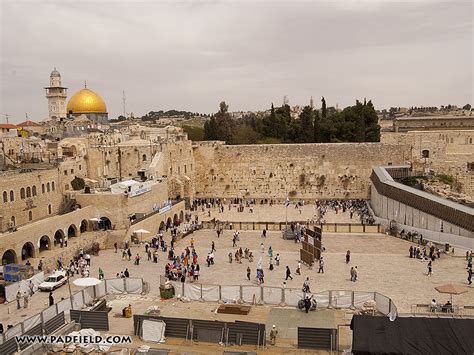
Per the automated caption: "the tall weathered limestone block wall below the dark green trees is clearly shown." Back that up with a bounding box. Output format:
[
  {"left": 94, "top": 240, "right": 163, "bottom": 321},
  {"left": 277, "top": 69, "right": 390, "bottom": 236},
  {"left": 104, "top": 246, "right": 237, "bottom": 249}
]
[{"left": 194, "top": 142, "right": 411, "bottom": 199}]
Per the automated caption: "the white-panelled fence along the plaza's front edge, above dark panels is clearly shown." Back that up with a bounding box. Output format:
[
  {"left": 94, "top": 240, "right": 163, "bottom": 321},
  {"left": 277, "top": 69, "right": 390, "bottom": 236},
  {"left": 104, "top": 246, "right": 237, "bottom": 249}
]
[{"left": 171, "top": 281, "right": 397, "bottom": 316}]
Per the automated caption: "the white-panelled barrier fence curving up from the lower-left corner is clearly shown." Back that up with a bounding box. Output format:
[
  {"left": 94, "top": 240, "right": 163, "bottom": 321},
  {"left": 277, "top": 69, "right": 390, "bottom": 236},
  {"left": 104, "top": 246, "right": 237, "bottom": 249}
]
[{"left": 0, "top": 278, "right": 146, "bottom": 352}]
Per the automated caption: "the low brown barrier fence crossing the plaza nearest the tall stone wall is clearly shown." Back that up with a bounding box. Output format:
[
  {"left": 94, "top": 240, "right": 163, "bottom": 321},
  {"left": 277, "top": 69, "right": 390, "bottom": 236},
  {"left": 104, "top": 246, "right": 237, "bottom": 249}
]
[{"left": 201, "top": 220, "right": 382, "bottom": 233}]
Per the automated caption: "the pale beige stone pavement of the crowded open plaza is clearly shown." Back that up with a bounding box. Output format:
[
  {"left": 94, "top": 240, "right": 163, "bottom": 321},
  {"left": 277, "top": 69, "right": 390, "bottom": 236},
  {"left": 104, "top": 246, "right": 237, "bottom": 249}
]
[{"left": 0, "top": 206, "right": 474, "bottom": 350}]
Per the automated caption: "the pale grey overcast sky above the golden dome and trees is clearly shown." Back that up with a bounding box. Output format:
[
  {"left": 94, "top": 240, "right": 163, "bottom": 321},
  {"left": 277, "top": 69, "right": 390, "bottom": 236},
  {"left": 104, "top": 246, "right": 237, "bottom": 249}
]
[{"left": 0, "top": 0, "right": 473, "bottom": 122}]
